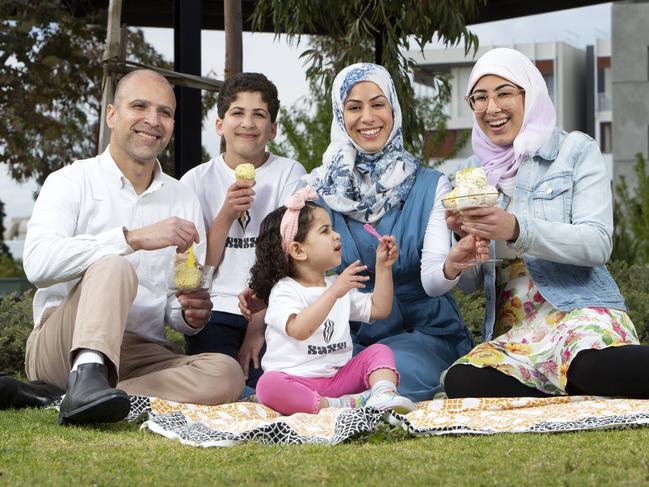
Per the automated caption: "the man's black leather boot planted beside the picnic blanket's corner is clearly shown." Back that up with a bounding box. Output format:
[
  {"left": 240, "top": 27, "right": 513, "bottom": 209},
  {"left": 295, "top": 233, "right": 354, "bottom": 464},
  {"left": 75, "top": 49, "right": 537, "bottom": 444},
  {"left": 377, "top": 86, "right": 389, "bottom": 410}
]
[{"left": 59, "top": 364, "right": 131, "bottom": 424}]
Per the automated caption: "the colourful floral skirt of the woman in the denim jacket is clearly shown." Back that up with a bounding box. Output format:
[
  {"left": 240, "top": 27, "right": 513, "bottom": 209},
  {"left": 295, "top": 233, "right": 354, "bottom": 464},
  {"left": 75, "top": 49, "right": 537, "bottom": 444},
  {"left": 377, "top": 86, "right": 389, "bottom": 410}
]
[{"left": 453, "top": 259, "right": 639, "bottom": 394}]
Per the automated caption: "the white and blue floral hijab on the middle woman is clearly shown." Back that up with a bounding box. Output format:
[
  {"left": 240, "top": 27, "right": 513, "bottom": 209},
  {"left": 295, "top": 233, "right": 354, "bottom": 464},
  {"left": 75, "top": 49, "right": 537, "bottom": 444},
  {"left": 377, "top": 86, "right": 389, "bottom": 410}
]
[{"left": 303, "top": 63, "right": 419, "bottom": 223}]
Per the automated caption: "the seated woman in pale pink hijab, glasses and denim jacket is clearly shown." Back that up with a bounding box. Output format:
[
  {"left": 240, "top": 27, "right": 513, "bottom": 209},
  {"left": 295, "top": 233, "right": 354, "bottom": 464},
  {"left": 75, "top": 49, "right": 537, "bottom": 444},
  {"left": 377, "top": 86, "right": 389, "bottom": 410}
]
[{"left": 444, "top": 49, "right": 649, "bottom": 398}]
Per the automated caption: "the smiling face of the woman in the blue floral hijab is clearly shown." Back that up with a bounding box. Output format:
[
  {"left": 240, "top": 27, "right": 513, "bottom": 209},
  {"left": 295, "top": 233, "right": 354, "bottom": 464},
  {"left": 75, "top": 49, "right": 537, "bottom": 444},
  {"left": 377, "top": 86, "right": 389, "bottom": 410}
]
[{"left": 343, "top": 81, "right": 394, "bottom": 154}]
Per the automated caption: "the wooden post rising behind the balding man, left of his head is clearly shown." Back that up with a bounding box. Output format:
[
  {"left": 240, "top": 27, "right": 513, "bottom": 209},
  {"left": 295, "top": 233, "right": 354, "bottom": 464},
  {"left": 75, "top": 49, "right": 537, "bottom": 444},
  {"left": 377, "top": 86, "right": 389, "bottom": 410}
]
[{"left": 97, "top": 0, "right": 123, "bottom": 154}]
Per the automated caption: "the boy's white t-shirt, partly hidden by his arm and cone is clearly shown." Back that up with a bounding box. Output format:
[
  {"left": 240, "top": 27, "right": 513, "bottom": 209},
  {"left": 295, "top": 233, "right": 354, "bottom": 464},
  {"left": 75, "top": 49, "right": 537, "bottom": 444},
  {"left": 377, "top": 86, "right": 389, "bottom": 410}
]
[{"left": 180, "top": 154, "right": 306, "bottom": 315}]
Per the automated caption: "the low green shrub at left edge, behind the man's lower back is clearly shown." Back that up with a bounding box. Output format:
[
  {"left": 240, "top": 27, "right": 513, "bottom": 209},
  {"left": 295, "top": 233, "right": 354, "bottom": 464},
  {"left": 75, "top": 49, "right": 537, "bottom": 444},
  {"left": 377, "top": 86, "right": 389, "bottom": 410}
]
[{"left": 0, "top": 291, "right": 34, "bottom": 375}]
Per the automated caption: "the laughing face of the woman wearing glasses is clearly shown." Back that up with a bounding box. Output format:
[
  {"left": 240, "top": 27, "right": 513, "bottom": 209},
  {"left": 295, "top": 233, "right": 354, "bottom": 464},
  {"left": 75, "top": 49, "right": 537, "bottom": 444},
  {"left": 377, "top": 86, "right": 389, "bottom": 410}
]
[{"left": 471, "top": 74, "right": 525, "bottom": 147}]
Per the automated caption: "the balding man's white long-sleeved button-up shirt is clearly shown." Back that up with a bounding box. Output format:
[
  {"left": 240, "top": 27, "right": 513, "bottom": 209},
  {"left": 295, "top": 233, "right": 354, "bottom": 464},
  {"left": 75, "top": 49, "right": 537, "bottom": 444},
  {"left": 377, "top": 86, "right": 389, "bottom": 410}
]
[{"left": 23, "top": 147, "right": 206, "bottom": 341}]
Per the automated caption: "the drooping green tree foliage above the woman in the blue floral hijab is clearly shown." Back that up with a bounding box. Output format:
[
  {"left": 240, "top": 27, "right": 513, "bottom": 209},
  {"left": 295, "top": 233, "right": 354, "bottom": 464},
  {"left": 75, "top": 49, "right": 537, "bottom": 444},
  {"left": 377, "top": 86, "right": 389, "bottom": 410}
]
[{"left": 252, "top": 0, "right": 484, "bottom": 146}]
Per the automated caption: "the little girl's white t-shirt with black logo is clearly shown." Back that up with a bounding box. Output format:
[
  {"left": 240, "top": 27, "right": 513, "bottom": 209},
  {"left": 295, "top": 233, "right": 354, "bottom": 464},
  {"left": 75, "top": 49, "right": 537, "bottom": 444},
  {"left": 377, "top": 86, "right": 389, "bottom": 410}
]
[{"left": 261, "top": 276, "right": 372, "bottom": 377}]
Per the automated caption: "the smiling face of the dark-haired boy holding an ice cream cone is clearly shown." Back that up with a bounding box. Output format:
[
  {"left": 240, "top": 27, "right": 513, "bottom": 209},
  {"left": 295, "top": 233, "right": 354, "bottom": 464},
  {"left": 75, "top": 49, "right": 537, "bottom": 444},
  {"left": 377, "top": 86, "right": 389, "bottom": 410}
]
[{"left": 216, "top": 91, "right": 277, "bottom": 167}]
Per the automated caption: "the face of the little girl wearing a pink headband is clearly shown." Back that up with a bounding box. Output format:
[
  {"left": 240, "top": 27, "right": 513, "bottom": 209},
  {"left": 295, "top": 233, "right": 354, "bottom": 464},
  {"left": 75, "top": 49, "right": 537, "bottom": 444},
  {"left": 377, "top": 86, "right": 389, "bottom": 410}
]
[{"left": 300, "top": 207, "right": 342, "bottom": 273}]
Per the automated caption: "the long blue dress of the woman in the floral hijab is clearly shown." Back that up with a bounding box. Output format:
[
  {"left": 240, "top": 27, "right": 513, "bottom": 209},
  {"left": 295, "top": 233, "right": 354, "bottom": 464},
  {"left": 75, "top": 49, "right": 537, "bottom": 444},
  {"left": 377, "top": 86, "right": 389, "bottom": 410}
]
[{"left": 319, "top": 168, "right": 473, "bottom": 401}]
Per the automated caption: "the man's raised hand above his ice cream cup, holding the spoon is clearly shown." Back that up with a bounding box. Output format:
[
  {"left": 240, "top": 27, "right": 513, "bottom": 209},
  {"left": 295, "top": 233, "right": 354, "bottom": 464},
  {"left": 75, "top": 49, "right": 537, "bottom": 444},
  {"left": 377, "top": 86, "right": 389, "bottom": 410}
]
[{"left": 125, "top": 216, "right": 199, "bottom": 253}]
